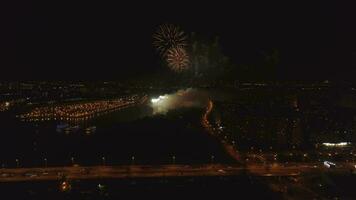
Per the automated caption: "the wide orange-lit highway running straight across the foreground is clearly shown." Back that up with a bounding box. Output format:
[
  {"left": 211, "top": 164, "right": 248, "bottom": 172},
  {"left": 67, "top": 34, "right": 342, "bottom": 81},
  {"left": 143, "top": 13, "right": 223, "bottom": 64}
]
[{"left": 0, "top": 163, "right": 355, "bottom": 182}]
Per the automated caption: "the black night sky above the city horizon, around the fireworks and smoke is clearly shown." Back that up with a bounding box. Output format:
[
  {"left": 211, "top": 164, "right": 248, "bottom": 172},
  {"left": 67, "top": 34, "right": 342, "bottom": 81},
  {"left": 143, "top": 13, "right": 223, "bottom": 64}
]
[{"left": 0, "top": 1, "right": 356, "bottom": 80}]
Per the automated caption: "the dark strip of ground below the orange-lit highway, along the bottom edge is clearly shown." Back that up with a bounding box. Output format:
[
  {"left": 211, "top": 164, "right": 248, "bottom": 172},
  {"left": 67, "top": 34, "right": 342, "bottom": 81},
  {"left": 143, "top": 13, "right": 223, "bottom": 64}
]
[{"left": 0, "top": 173, "right": 356, "bottom": 200}]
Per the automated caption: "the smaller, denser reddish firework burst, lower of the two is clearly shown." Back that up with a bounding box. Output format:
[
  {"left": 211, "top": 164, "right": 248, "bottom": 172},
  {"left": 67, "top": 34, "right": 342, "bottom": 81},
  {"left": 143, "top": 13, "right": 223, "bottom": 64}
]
[{"left": 166, "top": 47, "right": 190, "bottom": 72}]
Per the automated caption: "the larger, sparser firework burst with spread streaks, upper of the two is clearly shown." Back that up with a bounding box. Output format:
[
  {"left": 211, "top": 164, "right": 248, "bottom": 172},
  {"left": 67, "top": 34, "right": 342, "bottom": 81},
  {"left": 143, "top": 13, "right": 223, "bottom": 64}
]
[{"left": 153, "top": 24, "right": 187, "bottom": 56}]
